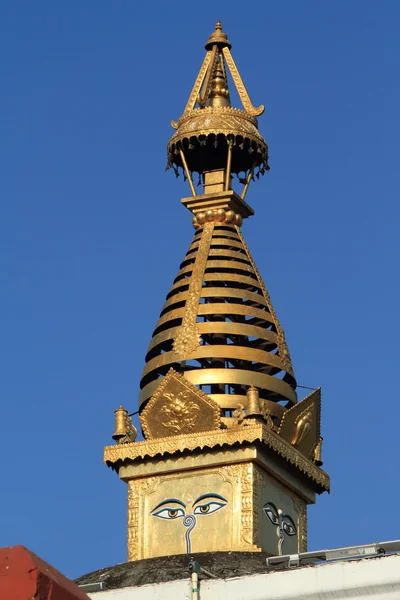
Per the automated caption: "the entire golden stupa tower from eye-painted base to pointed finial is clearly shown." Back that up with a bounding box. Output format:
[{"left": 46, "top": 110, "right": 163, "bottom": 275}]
[{"left": 105, "top": 22, "right": 329, "bottom": 560}]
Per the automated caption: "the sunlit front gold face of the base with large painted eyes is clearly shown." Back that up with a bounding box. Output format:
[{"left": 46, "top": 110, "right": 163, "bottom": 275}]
[{"left": 128, "top": 462, "right": 262, "bottom": 561}]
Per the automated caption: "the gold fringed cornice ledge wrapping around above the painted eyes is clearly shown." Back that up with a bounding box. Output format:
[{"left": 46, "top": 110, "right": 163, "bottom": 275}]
[{"left": 104, "top": 423, "right": 330, "bottom": 491}]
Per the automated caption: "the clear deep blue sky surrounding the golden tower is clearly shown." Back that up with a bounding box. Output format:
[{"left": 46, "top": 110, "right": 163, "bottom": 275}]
[{"left": 0, "top": 0, "right": 400, "bottom": 577}]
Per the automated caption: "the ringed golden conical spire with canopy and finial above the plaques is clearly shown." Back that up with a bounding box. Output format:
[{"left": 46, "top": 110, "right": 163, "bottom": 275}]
[{"left": 140, "top": 21, "right": 297, "bottom": 419}]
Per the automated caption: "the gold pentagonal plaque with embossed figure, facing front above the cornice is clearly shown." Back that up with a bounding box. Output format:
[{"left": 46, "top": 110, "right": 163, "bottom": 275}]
[{"left": 139, "top": 369, "right": 221, "bottom": 439}]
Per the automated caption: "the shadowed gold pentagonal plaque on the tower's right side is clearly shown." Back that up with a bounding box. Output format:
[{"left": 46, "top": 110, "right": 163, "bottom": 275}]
[{"left": 279, "top": 388, "right": 321, "bottom": 459}]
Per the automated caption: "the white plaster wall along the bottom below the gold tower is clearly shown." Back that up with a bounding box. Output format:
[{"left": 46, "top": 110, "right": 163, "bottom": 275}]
[{"left": 88, "top": 554, "right": 400, "bottom": 600}]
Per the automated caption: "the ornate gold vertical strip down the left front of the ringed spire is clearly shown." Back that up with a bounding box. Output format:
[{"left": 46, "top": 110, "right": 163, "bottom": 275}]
[{"left": 173, "top": 222, "right": 214, "bottom": 360}]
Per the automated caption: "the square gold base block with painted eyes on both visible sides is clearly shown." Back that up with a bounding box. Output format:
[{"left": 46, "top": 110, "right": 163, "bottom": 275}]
[{"left": 128, "top": 462, "right": 304, "bottom": 560}]
